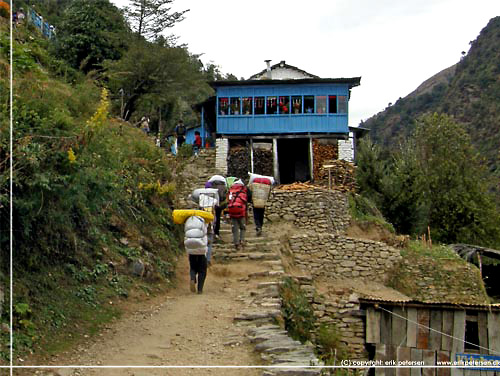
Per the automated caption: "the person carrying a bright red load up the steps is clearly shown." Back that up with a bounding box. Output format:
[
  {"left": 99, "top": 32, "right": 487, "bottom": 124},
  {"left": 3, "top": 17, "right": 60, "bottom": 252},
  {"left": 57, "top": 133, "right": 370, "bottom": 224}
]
[{"left": 227, "top": 180, "right": 251, "bottom": 250}]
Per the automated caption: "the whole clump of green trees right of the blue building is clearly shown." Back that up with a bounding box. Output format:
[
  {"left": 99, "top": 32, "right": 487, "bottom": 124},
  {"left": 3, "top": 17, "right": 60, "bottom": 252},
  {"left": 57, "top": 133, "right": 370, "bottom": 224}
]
[{"left": 356, "top": 114, "right": 500, "bottom": 247}]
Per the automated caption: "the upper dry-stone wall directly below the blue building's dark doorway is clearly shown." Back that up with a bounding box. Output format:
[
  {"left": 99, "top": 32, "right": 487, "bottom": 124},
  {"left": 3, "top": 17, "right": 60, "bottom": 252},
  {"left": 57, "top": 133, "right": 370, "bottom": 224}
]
[{"left": 266, "top": 189, "right": 350, "bottom": 234}]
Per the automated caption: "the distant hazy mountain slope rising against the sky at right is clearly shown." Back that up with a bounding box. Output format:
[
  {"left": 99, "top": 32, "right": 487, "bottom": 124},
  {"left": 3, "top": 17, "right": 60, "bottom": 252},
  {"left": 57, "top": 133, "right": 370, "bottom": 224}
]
[{"left": 363, "top": 17, "right": 500, "bottom": 176}]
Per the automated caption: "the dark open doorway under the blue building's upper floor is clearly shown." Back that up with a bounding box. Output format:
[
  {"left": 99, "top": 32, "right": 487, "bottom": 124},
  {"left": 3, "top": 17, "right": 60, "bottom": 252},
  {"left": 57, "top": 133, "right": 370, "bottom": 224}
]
[{"left": 278, "top": 138, "right": 311, "bottom": 184}]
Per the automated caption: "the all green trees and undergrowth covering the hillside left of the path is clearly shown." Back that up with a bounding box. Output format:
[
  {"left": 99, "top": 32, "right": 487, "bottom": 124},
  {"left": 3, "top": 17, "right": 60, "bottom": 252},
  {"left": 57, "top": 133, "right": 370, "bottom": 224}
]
[{"left": 0, "top": 0, "right": 230, "bottom": 362}]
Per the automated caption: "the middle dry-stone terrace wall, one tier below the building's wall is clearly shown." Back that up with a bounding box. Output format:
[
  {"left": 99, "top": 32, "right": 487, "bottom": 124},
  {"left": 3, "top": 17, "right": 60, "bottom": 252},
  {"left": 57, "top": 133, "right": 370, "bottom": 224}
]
[{"left": 289, "top": 231, "right": 401, "bottom": 282}]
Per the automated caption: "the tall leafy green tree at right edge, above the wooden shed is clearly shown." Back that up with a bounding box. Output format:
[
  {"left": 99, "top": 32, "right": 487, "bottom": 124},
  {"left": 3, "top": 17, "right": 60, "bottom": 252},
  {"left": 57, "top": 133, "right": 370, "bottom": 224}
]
[{"left": 412, "top": 113, "right": 500, "bottom": 245}]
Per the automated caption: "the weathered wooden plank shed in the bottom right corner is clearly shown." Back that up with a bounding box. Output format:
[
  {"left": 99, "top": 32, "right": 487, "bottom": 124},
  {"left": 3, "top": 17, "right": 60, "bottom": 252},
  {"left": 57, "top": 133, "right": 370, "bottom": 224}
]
[{"left": 360, "top": 299, "right": 500, "bottom": 376}]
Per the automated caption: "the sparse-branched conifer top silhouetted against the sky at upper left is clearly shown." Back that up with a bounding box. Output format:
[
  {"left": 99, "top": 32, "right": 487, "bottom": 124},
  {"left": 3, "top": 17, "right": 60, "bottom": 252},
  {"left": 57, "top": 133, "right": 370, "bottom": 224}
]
[{"left": 124, "top": 0, "right": 189, "bottom": 40}]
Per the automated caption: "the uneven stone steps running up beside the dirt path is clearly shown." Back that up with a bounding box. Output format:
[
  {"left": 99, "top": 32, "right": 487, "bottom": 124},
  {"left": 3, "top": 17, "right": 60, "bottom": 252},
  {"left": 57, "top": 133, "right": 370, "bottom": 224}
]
[{"left": 213, "top": 221, "right": 323, "bottom": 376}]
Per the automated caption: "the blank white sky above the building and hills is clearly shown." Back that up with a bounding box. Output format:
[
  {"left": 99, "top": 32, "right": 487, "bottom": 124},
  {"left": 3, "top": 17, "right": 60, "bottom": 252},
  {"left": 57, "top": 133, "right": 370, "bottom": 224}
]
[{"left": 111, "top": 0, "right": 500, "bottom": 126}]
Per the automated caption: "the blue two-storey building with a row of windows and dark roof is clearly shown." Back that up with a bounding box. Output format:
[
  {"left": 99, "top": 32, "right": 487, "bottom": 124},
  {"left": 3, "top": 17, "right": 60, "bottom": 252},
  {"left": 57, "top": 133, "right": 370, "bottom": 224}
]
[{"left": 200, "top": 60, "right": 361, "bottom": 183}]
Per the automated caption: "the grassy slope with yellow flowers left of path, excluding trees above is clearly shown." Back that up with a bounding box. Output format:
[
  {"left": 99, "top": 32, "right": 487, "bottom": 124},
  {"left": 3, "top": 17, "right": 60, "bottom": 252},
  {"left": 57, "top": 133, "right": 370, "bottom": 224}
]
[{"left": 0, "top": 24, "right": 187, "bottom": 362}]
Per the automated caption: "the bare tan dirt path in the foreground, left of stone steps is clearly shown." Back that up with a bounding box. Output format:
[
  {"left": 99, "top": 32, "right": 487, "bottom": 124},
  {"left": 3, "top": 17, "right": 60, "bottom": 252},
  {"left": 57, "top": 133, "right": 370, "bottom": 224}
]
[{"left": 28, "top": 257, "right": 262, "bottom": 376}]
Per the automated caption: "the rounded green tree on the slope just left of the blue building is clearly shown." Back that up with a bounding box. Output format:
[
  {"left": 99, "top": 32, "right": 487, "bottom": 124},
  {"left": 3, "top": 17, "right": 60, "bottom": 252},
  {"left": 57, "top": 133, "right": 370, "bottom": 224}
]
[{"left": 106, "top": 40, "right": 211, "bottom": 121}]
